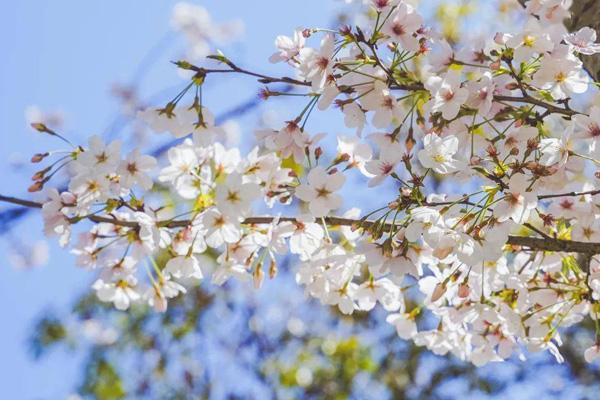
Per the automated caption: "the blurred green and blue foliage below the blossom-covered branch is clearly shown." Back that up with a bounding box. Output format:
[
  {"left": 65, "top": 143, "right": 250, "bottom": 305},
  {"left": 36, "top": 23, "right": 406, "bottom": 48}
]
[{"left": 30, "top": 273, "right": 600, "bottom": 399}]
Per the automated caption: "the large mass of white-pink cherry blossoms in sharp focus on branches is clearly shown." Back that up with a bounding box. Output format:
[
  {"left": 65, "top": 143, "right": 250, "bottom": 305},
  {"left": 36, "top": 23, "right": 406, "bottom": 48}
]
[{"left": 21, "top": 0, "right": 600, "bottom": 365}]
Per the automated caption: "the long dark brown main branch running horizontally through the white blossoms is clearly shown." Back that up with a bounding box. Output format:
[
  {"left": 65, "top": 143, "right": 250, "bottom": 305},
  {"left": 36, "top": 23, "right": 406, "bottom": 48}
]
[{"left": 0, "top": 192, "right": 600, "bottom": 255}]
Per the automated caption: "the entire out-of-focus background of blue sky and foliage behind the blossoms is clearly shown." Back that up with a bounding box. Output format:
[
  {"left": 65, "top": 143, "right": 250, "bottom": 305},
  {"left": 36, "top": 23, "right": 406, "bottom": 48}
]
[{"left": 0, "top": 0, "right": 600, "bottom": 399}]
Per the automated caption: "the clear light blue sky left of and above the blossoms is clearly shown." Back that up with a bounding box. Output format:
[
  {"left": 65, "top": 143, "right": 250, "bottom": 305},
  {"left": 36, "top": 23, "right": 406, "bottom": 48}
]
[{"left": 0, "top": 0, "right": 342, "bottom": 399}]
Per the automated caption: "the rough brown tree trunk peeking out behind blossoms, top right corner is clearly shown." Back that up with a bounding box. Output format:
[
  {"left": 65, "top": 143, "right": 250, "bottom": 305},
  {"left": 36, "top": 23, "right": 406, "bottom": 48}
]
[{"left": 565, "top": 0, "right": 600, "bottom": 81}]
